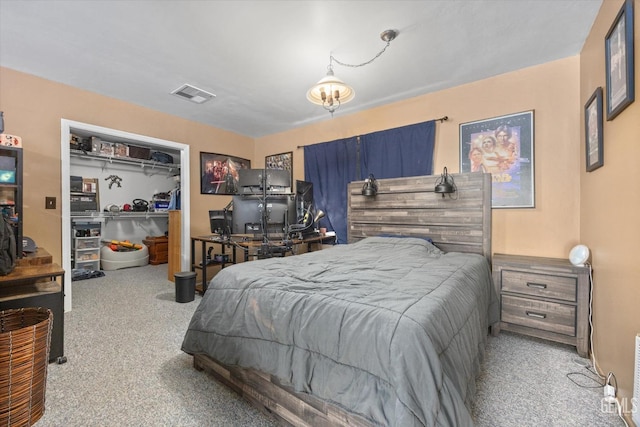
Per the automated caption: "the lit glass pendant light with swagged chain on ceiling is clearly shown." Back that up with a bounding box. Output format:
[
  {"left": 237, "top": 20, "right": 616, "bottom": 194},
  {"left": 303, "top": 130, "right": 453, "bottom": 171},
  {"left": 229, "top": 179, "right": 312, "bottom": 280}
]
[{"left": 307, "top": 30, "right": 398, "bottom": 116}]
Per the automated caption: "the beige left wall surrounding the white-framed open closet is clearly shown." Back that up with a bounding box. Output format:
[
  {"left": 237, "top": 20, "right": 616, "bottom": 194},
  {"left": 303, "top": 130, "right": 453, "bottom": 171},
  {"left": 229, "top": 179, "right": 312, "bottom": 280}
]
[{"left": 0, "top": 67, "right": 254, "bottom": 262}]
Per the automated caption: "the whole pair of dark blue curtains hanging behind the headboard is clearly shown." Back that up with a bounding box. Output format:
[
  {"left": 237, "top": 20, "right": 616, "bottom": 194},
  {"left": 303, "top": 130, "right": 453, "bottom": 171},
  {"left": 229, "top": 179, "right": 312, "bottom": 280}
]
[{"left": 304, "top": 120, "right": 435, "bottom": 243}]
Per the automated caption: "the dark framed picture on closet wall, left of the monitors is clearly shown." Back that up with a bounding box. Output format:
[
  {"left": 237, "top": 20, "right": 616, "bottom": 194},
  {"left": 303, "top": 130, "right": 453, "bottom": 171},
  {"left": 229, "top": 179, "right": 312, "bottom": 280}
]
[{"left": 200, "top": 152, "right": 251, "bottom": 194}]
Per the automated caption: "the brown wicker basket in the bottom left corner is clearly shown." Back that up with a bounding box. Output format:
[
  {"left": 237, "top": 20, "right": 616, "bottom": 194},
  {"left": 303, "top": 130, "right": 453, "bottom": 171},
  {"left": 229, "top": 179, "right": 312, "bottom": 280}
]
[{"left": 0, "top": 307, "right": 53, "bottom": 426}]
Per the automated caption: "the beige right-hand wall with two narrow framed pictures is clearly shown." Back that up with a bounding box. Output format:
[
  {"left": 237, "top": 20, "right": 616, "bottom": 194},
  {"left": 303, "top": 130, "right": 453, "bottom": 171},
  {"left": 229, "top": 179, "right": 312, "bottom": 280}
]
[{"left": 580, "top": 0, "right": 640, "bottom": 405}]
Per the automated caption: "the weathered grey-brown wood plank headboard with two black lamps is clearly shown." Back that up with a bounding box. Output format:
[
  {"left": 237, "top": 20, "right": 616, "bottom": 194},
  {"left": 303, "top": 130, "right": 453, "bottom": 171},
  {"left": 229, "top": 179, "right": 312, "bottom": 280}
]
[{"left": 347, "top": 172, "right": 491, "bottom": 263}]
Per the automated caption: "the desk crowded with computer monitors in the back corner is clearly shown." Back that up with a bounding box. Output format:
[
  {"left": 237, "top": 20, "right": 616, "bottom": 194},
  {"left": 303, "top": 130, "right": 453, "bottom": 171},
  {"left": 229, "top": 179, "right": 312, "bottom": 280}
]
[{"left": 191, "top": 169, "right": 335, "bottom": 293}]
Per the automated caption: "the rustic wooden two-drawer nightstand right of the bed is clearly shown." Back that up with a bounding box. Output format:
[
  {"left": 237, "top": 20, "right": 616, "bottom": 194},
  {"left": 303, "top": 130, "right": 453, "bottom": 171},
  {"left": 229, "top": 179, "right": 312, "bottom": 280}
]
[{"left": 493, "top": 254, "right": 590, "bottom": 357}]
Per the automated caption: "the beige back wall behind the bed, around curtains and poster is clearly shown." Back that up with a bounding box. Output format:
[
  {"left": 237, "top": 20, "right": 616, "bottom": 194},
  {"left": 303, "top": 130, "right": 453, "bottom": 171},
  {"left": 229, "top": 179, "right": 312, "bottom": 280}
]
[{"left": 256, "top": 57, "right": 582, "bottom": 257}]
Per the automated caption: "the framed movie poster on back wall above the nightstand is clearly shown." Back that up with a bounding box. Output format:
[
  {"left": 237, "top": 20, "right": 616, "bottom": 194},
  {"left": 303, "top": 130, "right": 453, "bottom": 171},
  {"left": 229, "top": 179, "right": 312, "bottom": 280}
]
[{"left": 460, "top": 110, "right": 535, "bottom": 208}]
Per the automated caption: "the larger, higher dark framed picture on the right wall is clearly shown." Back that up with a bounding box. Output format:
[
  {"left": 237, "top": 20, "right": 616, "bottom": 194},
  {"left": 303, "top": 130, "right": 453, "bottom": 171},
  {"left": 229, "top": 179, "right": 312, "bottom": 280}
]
[{"left": 604, "top": 0, "right": 635, "bottom": 120}]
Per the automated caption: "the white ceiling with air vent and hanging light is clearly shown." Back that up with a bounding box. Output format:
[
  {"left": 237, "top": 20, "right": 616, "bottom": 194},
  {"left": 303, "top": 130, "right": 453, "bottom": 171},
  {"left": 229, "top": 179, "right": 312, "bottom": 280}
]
[{"left": 0, "top": 0, "right": 602, "bottom": 137}]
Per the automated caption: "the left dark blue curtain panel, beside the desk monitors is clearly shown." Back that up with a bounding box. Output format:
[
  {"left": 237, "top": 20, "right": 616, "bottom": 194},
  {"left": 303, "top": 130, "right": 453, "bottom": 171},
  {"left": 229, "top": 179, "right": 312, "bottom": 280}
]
[{"left": 304, "top": 137, "right": 358, "bottom": 243}]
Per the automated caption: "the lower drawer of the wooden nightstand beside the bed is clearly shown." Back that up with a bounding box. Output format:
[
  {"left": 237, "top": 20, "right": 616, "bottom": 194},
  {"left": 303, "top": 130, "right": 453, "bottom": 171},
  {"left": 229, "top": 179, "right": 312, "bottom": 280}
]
[{"left": 502, "top": 295, "right": 576, "bottom": 336}]
